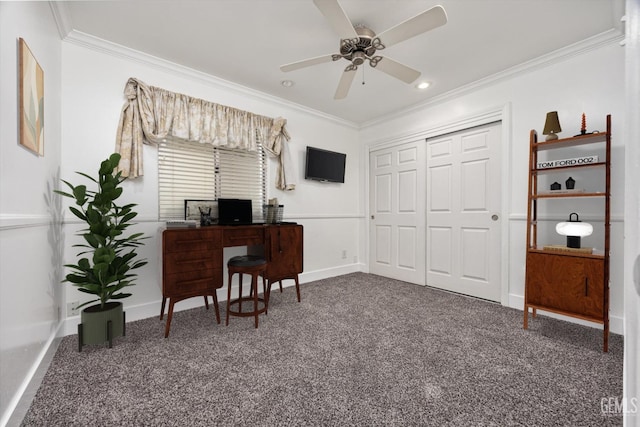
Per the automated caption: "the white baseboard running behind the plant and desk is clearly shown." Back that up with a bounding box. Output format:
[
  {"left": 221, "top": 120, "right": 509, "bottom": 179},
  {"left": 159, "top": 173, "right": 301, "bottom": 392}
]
[{"left": 60, "top": 264, "right": 364, "bottom": 336}]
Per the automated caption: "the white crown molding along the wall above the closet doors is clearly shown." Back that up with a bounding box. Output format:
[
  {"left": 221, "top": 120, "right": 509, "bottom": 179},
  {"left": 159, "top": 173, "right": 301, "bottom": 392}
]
[{"left": 360, "top": 28, "right": 624, "bottom": 128}]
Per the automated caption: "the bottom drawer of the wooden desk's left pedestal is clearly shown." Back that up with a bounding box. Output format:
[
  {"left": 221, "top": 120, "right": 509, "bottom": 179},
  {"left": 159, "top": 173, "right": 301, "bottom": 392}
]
[{"left": 162, "top": 268, "right": 222, "bottom": 298}]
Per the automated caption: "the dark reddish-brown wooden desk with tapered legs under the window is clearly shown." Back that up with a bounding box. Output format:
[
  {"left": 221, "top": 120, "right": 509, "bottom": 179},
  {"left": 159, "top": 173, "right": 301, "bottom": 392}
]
[{"left": 160, "top": 224, "right": 303, "bottom": 338}]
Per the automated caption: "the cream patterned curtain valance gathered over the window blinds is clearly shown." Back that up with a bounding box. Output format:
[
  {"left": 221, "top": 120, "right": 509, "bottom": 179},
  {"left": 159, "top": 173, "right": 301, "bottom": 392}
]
[{"left": 116, "top": 78, "right": 295, "bottom": 190}]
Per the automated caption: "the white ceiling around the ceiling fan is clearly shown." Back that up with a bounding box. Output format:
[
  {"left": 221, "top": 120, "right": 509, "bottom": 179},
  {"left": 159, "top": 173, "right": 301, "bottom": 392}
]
[{"left": 56, "top": 0, "right": 623, "bottom": 124}]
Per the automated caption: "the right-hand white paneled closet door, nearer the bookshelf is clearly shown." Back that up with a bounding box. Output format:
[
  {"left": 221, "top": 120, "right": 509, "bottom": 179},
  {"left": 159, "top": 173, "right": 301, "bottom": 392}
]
[{"left": 426, "top": 123, "right": 502, "bottom": 302}]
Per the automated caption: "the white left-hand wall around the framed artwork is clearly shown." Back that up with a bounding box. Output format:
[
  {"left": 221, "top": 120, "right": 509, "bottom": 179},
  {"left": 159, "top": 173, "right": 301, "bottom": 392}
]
[{"left": 0, "top": 2, "right": 64, "bottom": 425}]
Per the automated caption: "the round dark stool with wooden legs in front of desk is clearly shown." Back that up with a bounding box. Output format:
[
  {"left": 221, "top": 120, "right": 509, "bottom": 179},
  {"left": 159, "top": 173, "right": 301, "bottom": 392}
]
[{"left": 226, "top": 255, "right": 267, "bottom": 328}]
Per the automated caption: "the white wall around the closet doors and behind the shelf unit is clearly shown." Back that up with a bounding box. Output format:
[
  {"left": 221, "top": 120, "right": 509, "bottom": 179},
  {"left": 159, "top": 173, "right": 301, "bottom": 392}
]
[{"left": 360, "top": 42, "right": 626, "bottom": 333}]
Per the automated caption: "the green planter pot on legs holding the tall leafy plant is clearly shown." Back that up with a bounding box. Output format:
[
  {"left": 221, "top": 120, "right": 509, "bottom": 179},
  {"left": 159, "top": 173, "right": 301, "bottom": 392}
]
[{"left": 78, "top": 302, "right": 125, "bottom": 351}]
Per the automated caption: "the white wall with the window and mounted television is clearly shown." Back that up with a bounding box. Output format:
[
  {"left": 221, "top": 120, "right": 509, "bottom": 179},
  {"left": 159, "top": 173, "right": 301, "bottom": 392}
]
[{"left": 61, "top": 36, "right": 363, "bottom": 333}]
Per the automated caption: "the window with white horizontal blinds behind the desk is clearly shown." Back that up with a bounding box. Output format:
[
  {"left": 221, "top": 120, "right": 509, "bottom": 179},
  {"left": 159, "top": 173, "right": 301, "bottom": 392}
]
[{"left": 158, "top": 141, "right": 267, "bottom": 220}]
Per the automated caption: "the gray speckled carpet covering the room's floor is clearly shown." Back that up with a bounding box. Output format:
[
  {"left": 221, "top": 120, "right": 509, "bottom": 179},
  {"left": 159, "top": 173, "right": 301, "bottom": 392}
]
[{"left": 23, "top": 273, "right": 623, "bottom": 426}]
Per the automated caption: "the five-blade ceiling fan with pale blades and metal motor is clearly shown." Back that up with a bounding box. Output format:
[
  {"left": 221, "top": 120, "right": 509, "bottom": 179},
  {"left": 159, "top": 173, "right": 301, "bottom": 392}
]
[{"left": 280, "top": 0, "right": 447, "bottom": 99}]
